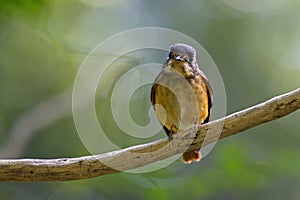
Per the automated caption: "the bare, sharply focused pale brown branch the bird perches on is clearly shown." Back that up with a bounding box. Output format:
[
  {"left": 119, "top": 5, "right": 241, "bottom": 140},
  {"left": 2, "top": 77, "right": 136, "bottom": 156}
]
[{"left": 0, "top": 88, "right": 300, "bottom": 182}]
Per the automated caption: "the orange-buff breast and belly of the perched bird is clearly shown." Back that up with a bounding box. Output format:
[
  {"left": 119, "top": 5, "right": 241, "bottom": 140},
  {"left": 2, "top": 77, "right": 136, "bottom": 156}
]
[{"left": 154, "top": 62, "right": 208, "bottom": 132}]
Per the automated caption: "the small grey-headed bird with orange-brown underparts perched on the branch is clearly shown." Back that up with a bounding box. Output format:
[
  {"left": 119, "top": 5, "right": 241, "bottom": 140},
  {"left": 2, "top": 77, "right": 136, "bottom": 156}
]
[{"left": 150, "top": 43, "right": 213, "bottom": 164}]
